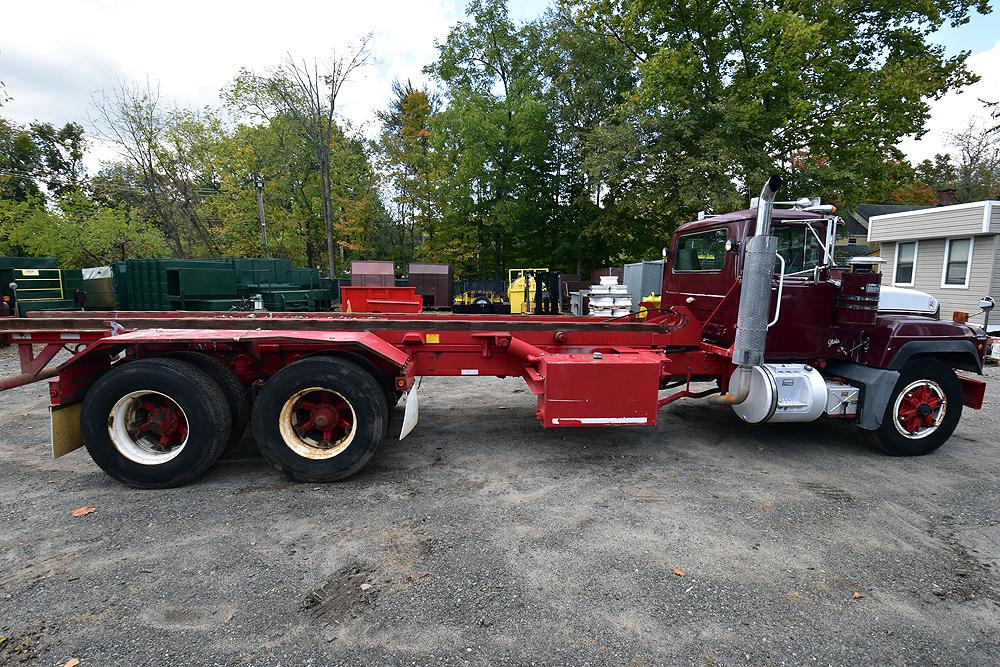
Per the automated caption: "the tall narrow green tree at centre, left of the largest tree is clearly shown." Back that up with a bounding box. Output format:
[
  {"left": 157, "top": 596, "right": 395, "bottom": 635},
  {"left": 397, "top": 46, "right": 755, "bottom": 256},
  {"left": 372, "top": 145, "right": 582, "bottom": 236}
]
[{"left": 427, "top": 0, "right": 558, "bottom": 278}]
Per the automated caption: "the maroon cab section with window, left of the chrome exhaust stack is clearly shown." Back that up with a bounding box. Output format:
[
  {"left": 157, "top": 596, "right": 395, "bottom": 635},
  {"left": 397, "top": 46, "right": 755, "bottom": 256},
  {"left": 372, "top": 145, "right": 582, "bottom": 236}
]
[{"left": 663, "top": 224, "right": 736, "bottom": 322}]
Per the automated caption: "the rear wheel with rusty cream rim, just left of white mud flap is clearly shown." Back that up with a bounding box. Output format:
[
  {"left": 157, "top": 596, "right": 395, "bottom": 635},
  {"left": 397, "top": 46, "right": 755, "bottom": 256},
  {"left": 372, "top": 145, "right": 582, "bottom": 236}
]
[{"left": 252, "top": 357, "right": 389, "bottom": 482}]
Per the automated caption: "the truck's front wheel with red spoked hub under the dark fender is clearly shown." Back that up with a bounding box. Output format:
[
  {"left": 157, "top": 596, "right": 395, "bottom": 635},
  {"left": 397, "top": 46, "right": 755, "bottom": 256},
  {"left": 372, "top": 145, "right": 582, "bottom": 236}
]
[{"left": 867, "top": 359, "right": 962, "bottom": 456}]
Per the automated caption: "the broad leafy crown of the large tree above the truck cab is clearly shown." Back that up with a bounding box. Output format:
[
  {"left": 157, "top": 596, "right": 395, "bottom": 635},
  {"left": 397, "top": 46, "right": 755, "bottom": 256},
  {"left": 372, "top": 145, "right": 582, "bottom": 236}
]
[{"left": 578, "top": 0, "right": 989, "bottom": 217}]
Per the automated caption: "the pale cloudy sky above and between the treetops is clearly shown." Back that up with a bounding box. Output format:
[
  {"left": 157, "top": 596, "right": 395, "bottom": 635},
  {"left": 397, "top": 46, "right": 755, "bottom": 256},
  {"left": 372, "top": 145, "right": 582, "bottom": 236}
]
[{"left": 0, "top": 0, "right": 1000, "bottom": 168}]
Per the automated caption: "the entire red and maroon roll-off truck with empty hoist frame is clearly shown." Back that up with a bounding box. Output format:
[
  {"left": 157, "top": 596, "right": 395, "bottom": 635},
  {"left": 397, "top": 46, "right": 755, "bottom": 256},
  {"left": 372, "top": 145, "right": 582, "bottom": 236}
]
[{"left": 0, "top": 179, "right": 986, "bottom": 488}]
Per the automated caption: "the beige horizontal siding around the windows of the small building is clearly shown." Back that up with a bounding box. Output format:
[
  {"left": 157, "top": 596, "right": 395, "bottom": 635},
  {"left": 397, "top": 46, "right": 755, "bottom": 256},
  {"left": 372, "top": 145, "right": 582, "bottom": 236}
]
[{"left": 881, "top": 235, "right": 1000, "bottom": 320}]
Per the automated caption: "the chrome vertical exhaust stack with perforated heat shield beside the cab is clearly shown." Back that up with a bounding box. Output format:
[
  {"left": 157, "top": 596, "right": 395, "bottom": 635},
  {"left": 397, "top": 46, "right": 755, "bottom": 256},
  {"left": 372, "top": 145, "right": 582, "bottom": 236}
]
[{"left": 712, "top": 176, "right": 781, "bottom": 405}]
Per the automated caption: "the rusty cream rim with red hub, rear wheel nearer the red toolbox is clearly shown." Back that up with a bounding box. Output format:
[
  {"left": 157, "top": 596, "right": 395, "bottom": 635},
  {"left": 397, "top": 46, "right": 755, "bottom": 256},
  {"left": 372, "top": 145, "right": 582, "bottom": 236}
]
[{"left": 278, "top": 387, "right": 358, "bottom": 460}]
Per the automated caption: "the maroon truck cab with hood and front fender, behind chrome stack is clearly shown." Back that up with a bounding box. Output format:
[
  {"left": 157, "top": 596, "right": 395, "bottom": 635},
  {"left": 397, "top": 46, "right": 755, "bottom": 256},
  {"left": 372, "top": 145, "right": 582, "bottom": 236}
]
[{"left": 662, "top": 209, "right": 987, "bottom": 429}]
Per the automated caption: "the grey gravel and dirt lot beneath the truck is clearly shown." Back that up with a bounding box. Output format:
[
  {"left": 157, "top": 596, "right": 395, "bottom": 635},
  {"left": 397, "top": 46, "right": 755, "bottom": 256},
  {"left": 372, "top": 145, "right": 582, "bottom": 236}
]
[{"left": 0, "top": 350, "right": 1000, "bottom": 667}]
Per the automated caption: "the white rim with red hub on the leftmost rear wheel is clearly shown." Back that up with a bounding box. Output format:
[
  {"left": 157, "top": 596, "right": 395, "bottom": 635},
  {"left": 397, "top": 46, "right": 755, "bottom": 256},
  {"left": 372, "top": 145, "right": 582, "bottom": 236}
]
[{"left": 108, "top": 390, "right": 189, "bottom": 466}]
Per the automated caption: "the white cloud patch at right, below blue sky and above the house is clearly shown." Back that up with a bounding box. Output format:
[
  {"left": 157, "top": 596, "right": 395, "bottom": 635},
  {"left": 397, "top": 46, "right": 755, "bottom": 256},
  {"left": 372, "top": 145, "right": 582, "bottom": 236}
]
[{"left": 899, "top": 42, "right": 1000, "bottom": 162}]
